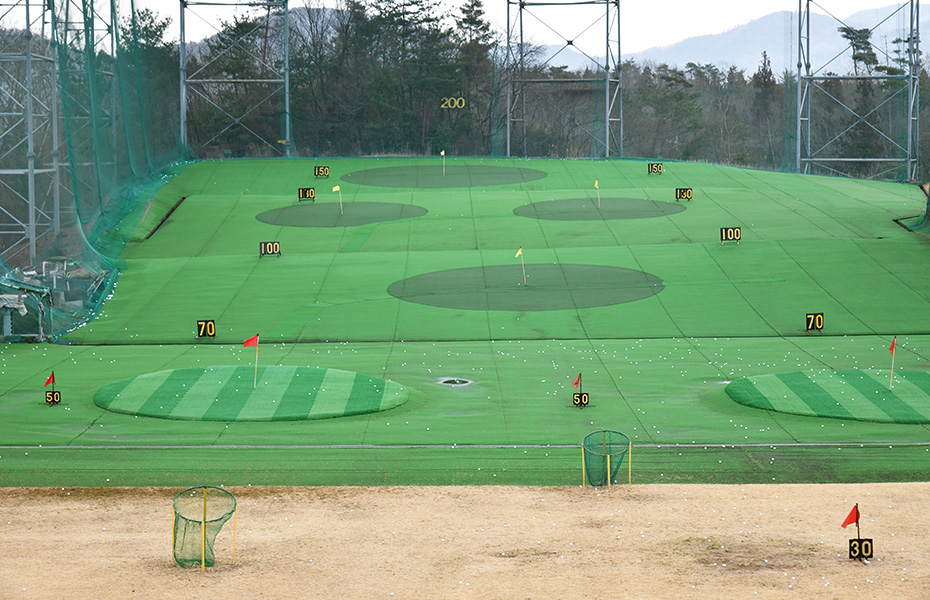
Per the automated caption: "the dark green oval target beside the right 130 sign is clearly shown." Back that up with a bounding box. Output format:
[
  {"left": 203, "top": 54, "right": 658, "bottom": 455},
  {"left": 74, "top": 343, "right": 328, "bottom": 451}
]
[{"left": 513, "top": 198, "right": 686, "bottom": 221}]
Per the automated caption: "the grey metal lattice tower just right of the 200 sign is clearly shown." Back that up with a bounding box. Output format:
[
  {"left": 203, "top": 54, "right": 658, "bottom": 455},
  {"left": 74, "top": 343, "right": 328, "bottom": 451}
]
[{"left": 505, "top": 0, "right": 623, "bottom": 157}]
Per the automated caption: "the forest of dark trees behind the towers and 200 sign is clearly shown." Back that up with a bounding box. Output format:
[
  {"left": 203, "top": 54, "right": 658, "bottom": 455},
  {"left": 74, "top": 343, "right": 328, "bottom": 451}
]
[{"left": 1, "top": 0, "right": 930, "bottom": 179}]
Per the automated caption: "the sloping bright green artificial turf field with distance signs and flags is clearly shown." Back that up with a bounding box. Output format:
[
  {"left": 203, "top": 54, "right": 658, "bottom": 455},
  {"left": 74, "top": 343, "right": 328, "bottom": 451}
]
[{"left": 0, "top": 158, "right": 930, "bottom": 486}]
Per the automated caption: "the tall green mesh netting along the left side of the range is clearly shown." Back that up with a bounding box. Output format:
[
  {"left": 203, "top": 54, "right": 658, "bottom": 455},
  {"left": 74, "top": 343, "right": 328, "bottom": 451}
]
[{"left": 0, "top": 1, "right": 181, "bottom": 340}]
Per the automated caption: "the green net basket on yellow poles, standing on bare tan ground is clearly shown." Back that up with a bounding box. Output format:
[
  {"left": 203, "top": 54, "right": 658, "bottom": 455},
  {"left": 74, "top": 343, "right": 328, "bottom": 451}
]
[{"left": 174, "top": 486, "right": 236, "bottom": 568}]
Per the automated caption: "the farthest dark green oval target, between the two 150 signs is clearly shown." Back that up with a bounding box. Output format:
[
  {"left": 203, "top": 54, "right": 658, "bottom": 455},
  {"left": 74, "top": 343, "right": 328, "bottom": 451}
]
[{"left": 341, "top": 160, "right": 547, "bottom": 189}]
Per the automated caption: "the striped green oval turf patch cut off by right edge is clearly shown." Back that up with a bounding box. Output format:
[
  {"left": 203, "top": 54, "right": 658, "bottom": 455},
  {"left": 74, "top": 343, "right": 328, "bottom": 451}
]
[{"left": 727, "top": 369, "right": 930, "bottom": 423}]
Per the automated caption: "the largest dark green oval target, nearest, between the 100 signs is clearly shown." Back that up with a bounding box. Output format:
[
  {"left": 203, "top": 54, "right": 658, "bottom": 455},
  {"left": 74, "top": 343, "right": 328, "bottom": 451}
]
[{"left": 387, "top": 262, "right": 665, "bottom": 311}]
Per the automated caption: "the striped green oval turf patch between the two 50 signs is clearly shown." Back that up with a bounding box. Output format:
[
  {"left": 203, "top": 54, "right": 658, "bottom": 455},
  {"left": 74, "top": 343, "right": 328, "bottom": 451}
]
[{"left": 94, "top": 366, "right": 409, "bottom": 421}]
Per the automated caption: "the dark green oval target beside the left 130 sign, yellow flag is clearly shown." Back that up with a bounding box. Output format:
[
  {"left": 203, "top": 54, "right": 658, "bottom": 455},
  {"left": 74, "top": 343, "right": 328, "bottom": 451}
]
[{"left": 255, "top": 202, "right": 428, "bottom": 227}]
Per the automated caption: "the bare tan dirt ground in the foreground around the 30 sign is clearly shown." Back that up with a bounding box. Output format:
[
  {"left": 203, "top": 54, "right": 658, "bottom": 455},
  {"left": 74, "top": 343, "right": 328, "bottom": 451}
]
[{"left": 0, "top": 483, "right": 930, "bottom": 600}]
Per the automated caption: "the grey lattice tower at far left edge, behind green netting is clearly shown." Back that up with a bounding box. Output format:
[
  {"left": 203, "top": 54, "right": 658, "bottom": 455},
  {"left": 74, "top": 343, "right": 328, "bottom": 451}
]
[{"left": 0, "top": 0, "right": 62, "bottom": 266}]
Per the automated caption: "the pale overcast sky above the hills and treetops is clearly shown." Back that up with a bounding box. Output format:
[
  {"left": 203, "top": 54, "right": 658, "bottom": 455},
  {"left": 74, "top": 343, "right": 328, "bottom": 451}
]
[{"left": 138, "top": 0, "right": 900, "bottom": 54}]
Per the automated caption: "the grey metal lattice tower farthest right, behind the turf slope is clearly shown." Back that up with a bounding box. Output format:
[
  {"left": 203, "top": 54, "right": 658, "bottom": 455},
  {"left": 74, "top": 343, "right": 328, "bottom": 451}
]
[{"left": 796, "top": 0, "right": 920, "bottom": 180}]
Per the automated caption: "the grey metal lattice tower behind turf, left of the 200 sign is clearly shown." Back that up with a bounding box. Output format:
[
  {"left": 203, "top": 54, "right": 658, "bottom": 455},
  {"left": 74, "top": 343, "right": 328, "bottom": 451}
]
[{"left": 180, "top": 0, "right": 293, "bottom": 156}]
